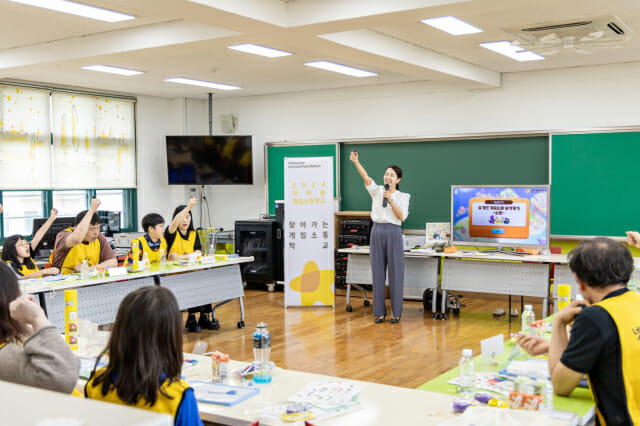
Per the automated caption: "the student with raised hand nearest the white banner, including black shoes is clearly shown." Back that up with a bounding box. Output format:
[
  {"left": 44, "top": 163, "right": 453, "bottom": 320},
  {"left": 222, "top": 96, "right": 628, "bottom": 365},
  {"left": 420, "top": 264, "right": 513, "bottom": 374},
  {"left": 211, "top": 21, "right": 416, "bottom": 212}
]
[{"left": 164, "top": 198, "right": 217, "bottom": 333}]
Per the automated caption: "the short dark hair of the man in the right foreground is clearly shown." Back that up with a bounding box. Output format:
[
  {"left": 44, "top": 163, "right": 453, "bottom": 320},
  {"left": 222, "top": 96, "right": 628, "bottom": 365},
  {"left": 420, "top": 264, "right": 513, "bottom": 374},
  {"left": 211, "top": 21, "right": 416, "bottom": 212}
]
[{"left": 569, "top": 237, "right": 633, "bottom": 287}]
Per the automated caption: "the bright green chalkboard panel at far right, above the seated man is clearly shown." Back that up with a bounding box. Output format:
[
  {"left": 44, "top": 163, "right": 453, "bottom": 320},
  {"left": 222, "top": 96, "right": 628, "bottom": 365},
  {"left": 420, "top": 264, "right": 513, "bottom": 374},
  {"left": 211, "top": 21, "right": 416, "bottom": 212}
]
[{"left": 551, "top": 132, "right": 640, "bottom": 237}]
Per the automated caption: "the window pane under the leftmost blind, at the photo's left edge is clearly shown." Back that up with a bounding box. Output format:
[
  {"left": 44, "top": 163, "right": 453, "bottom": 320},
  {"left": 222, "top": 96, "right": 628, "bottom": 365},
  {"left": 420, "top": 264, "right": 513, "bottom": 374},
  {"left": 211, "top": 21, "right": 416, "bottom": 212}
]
[{"left": 2, "top": 191, "right": 44, "bottom": 237}]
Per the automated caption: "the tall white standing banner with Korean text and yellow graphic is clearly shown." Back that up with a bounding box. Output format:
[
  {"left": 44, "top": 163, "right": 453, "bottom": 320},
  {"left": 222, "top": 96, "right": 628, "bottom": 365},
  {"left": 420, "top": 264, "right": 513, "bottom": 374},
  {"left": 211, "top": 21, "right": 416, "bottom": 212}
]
[{"left": 283, "top": 157, "right": 335, "bottom": 308}]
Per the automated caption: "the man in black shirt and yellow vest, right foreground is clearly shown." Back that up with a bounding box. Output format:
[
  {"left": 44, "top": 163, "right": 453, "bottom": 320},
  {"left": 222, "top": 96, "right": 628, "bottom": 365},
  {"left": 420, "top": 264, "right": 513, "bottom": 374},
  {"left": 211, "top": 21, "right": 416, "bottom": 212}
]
[{"left": 517, "top": 237, "right": 640, "bottom": 425}]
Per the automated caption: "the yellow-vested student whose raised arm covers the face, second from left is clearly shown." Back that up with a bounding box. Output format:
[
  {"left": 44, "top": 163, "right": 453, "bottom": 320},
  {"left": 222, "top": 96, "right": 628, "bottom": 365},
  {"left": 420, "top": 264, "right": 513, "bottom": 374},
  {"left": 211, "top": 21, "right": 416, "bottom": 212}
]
[{"left": 49, "top": 198, "right": 118, "bottom": 275}]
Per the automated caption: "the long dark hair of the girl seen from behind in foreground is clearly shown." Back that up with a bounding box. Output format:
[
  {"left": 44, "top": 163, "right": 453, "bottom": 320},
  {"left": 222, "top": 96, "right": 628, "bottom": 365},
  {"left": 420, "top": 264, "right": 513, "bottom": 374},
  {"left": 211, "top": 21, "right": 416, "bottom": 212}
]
[{"left": 94, "top": 286, "right": 183, "bottom": 406}]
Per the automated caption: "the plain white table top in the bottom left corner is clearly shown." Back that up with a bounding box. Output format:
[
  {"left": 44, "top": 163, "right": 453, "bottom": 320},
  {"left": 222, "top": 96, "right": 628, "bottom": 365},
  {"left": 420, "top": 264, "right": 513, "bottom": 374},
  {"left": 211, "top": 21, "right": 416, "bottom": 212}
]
[{"left": 0, "top": 381, "right": 173, "bottom": 426}]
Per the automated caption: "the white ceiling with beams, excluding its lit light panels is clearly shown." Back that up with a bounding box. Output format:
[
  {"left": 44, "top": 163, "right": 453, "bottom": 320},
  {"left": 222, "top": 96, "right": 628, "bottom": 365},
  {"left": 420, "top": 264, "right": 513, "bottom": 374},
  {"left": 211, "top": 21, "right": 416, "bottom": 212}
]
[{"left": 0, "top": 0, "right": 640, "bottom": 98}]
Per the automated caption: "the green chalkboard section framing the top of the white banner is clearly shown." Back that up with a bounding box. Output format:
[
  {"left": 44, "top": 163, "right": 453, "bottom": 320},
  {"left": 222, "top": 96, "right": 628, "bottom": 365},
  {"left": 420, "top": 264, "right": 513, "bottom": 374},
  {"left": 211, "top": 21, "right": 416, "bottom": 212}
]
[{"left": 266, "top": 143, "right": 338, "bottom": 214}]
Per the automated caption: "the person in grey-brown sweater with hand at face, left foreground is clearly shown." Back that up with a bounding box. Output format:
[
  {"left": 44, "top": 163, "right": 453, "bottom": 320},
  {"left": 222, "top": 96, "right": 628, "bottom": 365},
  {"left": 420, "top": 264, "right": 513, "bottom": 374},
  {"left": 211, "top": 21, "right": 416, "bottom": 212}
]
[{"left": 0, "top": 262, "right": 80, "bottom": 394}]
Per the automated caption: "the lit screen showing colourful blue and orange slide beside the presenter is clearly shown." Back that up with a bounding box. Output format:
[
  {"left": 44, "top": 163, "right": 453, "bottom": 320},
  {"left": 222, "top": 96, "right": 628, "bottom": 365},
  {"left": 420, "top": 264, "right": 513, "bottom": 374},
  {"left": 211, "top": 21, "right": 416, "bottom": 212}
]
[{"left": 451, "top": 185, "right": 551, "bottom": 248}]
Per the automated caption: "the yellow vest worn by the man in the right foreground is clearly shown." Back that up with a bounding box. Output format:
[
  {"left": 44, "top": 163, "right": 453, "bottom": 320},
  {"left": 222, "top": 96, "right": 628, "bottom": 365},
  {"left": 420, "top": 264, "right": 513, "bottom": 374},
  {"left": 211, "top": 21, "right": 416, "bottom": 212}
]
[{"left": 592, "top": 291, "right": 640, "bottom": 425}]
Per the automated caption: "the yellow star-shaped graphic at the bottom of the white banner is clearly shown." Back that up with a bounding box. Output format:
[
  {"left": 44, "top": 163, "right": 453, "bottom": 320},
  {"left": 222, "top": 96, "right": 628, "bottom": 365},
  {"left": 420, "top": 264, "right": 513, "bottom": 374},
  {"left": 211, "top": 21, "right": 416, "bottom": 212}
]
[{"left": 289, "top": 260, "right": 334, "bottom": 306}]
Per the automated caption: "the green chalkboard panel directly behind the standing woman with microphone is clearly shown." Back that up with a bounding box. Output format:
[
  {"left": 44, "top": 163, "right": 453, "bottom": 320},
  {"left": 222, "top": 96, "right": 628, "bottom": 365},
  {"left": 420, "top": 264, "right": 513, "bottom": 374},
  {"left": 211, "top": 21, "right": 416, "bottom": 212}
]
[{"left": 340, "top": 136, "right": 549, "bottom": 229}]
